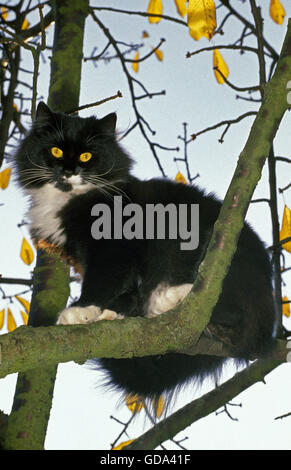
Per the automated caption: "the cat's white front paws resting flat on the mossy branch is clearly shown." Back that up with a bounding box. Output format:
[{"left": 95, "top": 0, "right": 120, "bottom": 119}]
[{"left": 57, "top": 305, "right": 124, "bottom": 325}]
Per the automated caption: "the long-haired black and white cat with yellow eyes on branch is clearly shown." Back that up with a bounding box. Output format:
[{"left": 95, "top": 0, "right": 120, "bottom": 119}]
[{"left": 15, "top": 102, "right": 277, "bottom": 400}]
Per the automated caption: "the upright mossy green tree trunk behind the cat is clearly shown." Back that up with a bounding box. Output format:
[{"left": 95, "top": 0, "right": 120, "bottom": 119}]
[{"left": 5, "top": 0, "right": 88, "bottom": 450}]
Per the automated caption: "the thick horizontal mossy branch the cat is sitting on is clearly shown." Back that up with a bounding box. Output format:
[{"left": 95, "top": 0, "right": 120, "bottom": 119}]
[{"left": 0, "top": 318, "right": 288, "bottom": 377}]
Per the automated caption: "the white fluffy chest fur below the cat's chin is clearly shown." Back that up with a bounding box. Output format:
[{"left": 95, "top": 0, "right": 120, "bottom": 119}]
[{"left": 27, "top": 179, "right": 93, "bottom": 245}]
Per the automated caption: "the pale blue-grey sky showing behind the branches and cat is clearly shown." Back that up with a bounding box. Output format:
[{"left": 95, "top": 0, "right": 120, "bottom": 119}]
[{"left": 0, "top": 0, "right": 291, "bottom": 450}]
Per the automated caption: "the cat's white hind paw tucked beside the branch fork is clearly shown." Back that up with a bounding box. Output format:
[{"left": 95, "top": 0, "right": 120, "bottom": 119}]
[{"left": 147, "top": 284, "right": 193, "bottom": 317}]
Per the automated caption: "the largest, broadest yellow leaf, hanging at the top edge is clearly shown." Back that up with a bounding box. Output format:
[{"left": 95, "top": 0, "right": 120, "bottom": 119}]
[{"left": 188, "top": 0, "right": 216, "bottom": 41}]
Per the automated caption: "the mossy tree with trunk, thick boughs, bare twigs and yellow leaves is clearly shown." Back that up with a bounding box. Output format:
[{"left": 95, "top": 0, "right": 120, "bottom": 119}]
[{"left": 0, "top": 0, "right": 291, "bottom": 449}]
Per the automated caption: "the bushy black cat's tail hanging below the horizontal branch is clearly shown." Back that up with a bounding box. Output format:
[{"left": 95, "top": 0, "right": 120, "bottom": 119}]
[{"left": 90, "top": 353, "right": 227, "bottom": 403}]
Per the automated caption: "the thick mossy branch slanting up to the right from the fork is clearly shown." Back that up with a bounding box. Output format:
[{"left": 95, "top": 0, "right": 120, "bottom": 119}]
[{"left": 173, "top": 20, "right": 291, "bottom": 345}]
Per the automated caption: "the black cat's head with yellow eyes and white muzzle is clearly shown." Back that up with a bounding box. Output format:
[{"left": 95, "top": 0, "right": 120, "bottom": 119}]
[{"left": 16, "top": 102, "right": 132, "bottom": 193}]
